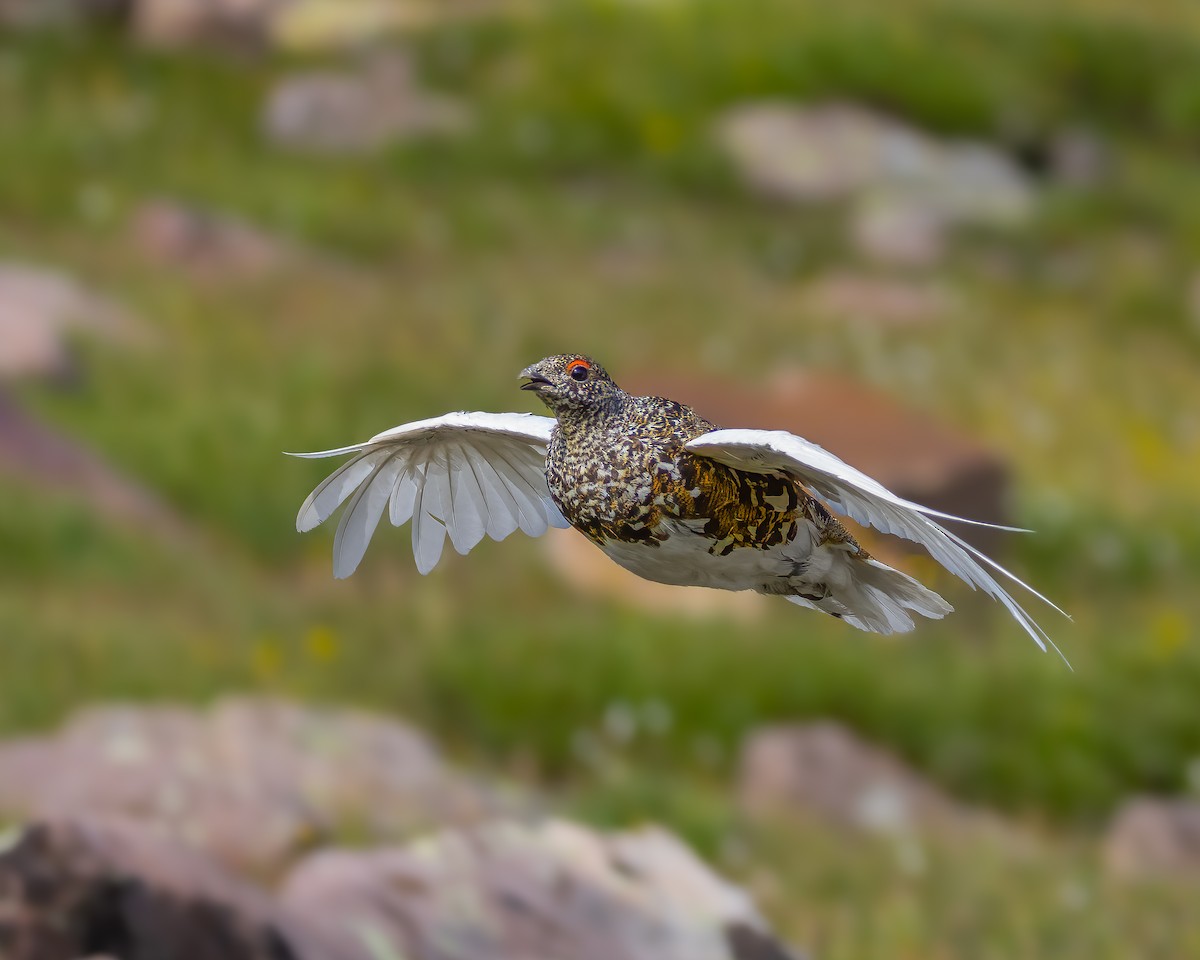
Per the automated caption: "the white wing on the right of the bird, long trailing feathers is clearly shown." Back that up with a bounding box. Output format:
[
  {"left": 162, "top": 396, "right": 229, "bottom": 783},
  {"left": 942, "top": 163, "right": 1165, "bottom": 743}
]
[{"left": 686, "top": 430, "right": 1066, "bottom": 655}]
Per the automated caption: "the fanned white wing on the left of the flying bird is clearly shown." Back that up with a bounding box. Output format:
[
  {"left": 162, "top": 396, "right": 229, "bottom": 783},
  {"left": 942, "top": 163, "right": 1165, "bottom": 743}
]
[{"left": 290, "top": 413, "right": 568, "bottom": 577}]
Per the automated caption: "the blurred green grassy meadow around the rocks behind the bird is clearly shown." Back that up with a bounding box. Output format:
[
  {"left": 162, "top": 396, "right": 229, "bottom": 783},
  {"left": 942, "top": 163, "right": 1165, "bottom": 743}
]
[{"left": 0, "top": 0, "right": 1200, "bottom": 958}]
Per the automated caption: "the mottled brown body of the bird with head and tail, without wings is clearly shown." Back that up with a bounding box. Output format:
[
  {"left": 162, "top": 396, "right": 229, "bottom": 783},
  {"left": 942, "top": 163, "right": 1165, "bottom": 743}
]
[{"left": 535, "top": 358, "right": 950, "bottom": 634}]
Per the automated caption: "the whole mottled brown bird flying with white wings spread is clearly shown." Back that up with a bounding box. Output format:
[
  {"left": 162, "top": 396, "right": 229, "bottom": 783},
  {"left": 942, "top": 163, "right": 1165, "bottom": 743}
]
[{"left": 295, "top": 354, "right": 1062, "bottom": 650}]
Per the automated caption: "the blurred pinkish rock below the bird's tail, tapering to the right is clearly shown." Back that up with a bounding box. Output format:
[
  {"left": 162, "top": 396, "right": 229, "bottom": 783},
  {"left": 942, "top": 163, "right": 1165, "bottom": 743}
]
[{"left": 738, "top": 722, "right": 998, "bottom": 835}]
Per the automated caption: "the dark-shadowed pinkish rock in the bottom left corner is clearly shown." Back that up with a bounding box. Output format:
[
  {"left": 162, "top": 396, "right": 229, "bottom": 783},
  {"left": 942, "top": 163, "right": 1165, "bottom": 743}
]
[{"left": 0, "top": 821, "right": 291, "bottom": 960}]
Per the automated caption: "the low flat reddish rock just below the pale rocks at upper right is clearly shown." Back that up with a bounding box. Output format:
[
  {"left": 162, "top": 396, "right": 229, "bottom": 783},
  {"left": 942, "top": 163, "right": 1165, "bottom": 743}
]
[{"left": 803, "top": 270, "right": 955, "bottom": 328}]
